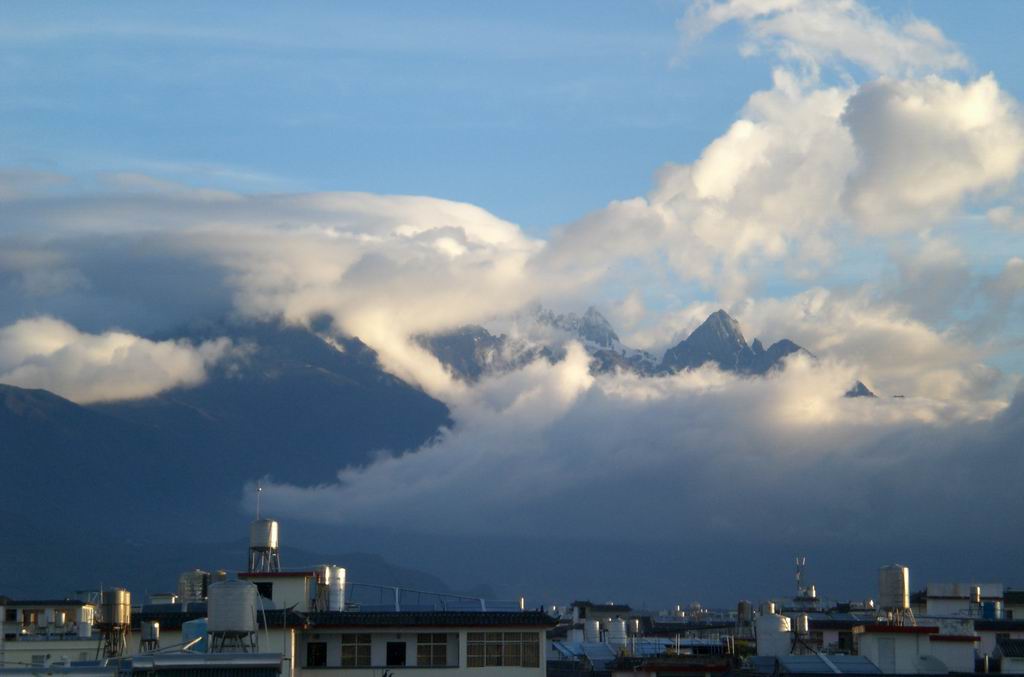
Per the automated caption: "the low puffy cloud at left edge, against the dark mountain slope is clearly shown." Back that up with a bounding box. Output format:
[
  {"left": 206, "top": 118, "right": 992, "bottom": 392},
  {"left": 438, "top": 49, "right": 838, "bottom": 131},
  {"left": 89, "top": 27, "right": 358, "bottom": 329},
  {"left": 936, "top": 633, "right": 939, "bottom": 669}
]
[{"left": 0, "top": 316, "right": 230, "bottom": 404}]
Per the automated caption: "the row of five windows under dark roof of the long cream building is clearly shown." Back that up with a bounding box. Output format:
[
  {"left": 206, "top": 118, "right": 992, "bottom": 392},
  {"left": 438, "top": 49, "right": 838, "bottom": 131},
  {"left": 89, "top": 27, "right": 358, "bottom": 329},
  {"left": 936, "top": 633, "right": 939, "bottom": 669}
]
[{"left": 306, "top": 632, "right": 541, "bottom": 668}]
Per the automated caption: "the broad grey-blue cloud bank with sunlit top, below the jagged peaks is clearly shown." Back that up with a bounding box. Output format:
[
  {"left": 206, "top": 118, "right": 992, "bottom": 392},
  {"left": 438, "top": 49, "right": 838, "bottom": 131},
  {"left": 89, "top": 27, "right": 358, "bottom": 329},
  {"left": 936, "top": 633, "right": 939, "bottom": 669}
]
[{"left": 256, "top": 349, "right": 1016, "bottom": 543}]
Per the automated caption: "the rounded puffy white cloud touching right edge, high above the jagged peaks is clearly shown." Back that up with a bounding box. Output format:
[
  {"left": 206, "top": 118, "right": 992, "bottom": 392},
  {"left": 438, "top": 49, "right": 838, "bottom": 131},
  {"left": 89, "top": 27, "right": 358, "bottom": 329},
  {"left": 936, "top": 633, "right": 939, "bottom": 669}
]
[{"left": 843, "top": 75, "right": 1024, "bottom": 232}]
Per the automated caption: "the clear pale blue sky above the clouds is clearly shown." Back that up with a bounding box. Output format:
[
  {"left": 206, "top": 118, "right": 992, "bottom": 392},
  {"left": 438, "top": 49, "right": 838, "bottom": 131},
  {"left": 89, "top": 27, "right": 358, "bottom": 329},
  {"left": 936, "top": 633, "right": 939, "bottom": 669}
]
[{"left": 0, "top": 1, "right": 1024, "bottom": 235}]
